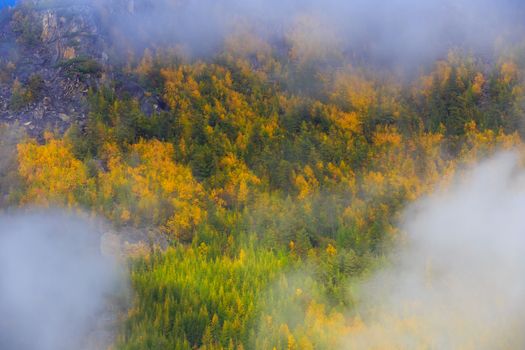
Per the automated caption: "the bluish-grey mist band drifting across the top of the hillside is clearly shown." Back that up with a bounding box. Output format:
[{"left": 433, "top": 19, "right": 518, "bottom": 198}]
[{"left": 94, "top": 0, "right": 525, "bottom": 64}]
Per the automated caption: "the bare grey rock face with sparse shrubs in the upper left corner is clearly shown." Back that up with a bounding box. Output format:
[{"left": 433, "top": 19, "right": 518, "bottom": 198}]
[{"left": 0, "top": 0, "right": 167, "bottom": 137}]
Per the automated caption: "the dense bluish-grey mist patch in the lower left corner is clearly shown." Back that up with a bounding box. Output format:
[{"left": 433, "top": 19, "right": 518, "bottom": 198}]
[{"left": 0, "top": 211, "right": 125, "bottom": 350}]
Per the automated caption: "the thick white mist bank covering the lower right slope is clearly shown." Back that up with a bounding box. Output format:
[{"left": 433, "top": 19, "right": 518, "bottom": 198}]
[{"left": 342, "top": 152, "right": 525, "bottom": 349}]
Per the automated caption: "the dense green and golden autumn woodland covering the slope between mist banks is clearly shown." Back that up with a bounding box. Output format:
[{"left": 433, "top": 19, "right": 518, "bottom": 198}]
[{"left": 1, "top": 2, "right": 525, "bottom": 350}]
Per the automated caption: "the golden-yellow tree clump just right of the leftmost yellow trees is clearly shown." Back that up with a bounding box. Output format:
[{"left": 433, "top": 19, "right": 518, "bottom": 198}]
[{"left": 99, "top": 140, "right": 207, "bottom": 239}]
